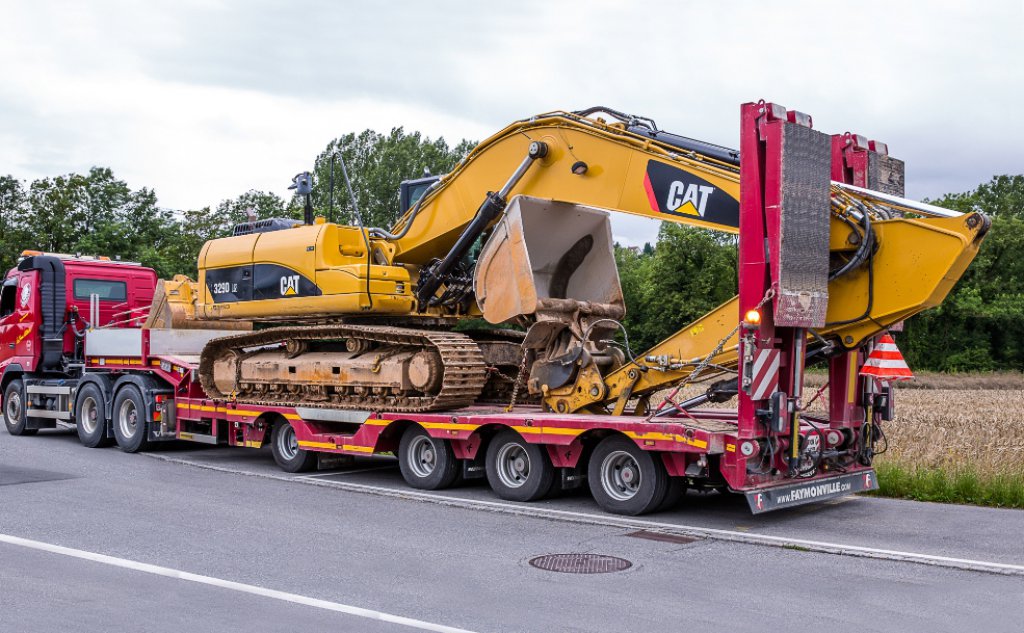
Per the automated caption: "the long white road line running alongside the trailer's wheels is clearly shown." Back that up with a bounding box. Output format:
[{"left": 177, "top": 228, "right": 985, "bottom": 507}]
[{"left": 143, "top": 453, "right": 1024, "bottom": 576}]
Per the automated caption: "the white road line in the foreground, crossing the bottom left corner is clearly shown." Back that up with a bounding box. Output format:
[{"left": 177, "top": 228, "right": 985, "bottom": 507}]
[{"left": 0, "top": 534, "right": 473, "bottom": 633}]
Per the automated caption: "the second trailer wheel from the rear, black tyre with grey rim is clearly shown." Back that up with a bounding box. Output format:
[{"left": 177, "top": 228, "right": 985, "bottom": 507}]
[{"left": 486, "top": 429, "right": 555, "bottom": 501}]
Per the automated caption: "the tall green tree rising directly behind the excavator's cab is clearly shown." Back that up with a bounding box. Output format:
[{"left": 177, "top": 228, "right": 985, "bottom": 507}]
[{"left": 309, "top": 127, "right": 476, "bottom": 227}]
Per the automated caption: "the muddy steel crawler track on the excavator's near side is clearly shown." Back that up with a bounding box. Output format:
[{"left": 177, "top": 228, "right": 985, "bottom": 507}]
[{"left": 199, "top": 325, "right": 487, "bottom": 413}]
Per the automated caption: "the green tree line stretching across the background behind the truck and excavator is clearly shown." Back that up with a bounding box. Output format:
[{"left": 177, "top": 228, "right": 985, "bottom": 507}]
[{"left": 0, "top": 128, "right": 1024, "bottom": 372}]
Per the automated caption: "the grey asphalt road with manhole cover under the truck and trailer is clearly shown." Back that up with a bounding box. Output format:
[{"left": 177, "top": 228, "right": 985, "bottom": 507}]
[{"left": 0, "top": 431, "right": 1024, "bottom": 633}]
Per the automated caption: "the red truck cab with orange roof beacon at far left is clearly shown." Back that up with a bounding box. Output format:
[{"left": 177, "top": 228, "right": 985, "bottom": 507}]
[{"left": 0, "top": 251, "right": 157, "bottom": 432}]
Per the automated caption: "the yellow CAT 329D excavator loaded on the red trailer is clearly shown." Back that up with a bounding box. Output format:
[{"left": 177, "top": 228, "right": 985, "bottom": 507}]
[{"left": 148, "top": 108, "right": 988, "bottom": 415}]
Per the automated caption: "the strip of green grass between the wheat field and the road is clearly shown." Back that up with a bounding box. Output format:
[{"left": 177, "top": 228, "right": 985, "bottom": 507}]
[{"left": 870, "top": 462, "right": 1024, "bottom": 509}]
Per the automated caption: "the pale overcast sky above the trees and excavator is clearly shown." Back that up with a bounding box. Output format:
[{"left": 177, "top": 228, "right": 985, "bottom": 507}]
[{"left": 0, "top": 0, "right": 1024, "bottom": 244}]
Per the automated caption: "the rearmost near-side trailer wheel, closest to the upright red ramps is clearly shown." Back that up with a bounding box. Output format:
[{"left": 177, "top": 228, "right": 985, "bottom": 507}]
[{"left": 587, "top": 435, "right": 670, "bottom": 516}]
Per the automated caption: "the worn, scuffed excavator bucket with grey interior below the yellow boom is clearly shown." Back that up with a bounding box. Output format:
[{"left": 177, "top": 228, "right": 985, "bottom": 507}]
[{"left": 473, "top": 196, "right": 626, "bottom": 324}]
